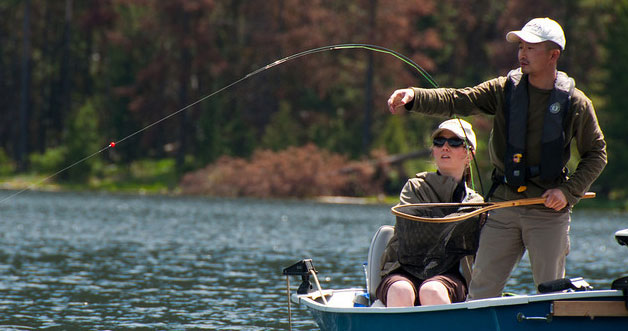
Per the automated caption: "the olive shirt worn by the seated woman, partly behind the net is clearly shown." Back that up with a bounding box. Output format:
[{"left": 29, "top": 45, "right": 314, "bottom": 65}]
[{"left": 381, "top": 172, "right": 484, "bottom": 281}]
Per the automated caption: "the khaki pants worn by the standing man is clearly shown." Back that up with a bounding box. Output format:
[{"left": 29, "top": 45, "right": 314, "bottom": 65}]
[{"left": 468, "top": 207, "right": 571, "bottom": 300}]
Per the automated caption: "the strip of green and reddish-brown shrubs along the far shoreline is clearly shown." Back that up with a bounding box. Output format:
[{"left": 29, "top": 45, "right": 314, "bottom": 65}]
[{"left": 0, "top": 144, "right": 628, "bottom": 211}]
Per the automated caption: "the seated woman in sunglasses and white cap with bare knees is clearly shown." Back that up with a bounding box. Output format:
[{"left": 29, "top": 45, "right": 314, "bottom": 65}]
[{"left": 376, "top": 119, "right": 483, "bottom": 307}]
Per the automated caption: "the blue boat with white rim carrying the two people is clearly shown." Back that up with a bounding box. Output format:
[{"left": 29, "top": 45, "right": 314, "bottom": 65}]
[{"left": 283, "top": 230, "right": 628, "bottom": 331}]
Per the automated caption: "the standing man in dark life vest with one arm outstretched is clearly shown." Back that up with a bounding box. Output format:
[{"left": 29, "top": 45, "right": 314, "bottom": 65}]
[{"left": 388, "top": 18, "right": 607, "bottom": 300}]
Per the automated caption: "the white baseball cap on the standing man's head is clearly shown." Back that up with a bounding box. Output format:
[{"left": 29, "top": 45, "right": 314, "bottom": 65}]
[{"left": 506, "top": 17, "right": 567, "bottom": 50}]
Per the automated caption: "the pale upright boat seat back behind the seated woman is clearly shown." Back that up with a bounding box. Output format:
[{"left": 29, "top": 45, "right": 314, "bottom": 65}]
[{"left": 366, "top": 225, "right": 395, "bottom": 302}]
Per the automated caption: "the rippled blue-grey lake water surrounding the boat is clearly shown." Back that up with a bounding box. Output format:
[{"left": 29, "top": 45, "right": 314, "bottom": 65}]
[{"left": 0, "top": 191, "right": 628, "bottom": 330}]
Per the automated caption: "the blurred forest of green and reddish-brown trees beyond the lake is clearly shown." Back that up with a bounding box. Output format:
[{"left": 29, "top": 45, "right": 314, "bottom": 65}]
[{"left": 0, "top": 0, "right": 628, "bottom": 208}]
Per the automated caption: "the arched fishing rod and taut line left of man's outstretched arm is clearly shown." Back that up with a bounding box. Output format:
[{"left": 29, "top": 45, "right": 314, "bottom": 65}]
[{"left": 0, "top": 44, "right": 438, "bottom": 204}]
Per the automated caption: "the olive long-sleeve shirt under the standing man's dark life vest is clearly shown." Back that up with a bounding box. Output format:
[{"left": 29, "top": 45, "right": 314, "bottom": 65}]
[{"left": 407, "top": 76, "right": 607, "bottom": 209}]
